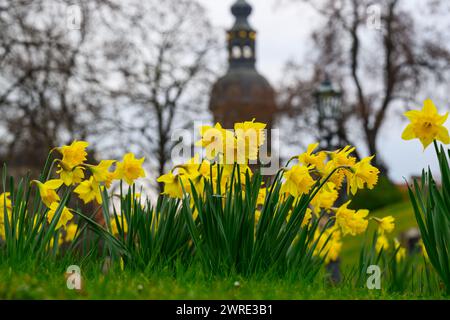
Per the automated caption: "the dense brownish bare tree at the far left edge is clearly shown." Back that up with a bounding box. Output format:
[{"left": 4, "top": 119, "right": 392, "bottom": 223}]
[{"left": 0, "top": 0, "right": 116, "bottom": 169}]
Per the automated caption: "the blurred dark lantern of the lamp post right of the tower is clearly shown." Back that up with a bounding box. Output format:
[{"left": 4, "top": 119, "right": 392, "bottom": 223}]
[{"left": 314, "top": 77, "right": 346, "bottom": 150}]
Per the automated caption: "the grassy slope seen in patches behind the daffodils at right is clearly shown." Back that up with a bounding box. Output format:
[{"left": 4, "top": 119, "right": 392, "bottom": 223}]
[{"left": 341, "top": 201, "right": 417, "bottom": 266}]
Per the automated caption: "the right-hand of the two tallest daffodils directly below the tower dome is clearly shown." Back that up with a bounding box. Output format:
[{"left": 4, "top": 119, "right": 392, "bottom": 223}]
[{"left": 234, "top": 119, "right": 267, "bottom": 164}]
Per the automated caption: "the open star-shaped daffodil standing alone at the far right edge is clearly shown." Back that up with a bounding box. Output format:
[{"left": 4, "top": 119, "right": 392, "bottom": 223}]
[{"left": 402, "top": 99, "right": 450, "bottom": 149}]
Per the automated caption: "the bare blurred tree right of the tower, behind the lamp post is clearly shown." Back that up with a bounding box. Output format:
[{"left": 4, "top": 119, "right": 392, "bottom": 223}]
[{"left": 283, "top": 0, "right": 450, "bottom": 172}]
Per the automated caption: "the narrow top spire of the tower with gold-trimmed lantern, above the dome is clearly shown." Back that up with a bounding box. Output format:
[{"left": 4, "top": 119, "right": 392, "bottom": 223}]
[{"left": 227, "top": 0, "right": 256, "bottom": 69}]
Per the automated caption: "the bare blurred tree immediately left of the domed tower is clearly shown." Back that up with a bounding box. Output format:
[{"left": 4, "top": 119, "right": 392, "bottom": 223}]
[{"left": 98, "top": 0, "right": 217, "bottom": 188}]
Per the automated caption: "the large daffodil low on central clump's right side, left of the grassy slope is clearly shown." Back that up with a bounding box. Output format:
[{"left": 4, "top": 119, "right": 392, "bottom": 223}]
[{"left": 336, "top": 201, "right": 369, "bottom": 236}]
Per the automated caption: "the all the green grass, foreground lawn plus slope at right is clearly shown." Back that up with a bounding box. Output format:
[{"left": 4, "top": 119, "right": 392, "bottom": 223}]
[{"left": 0, "top": 203, "right": 443, "bottom": 300}]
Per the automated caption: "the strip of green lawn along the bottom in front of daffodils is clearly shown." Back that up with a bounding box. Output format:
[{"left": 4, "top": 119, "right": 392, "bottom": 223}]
[{"left": 0, "top": 266, "right": 443, "bottom": 300}]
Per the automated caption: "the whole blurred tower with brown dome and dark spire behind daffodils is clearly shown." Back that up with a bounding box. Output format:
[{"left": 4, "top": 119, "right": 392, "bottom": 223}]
[{"left": 209, "top": 0, "right": 277, "bottom": 129}]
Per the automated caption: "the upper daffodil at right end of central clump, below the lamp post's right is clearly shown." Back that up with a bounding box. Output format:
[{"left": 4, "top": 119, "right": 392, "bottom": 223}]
[{"left": 348, "top": 156, "right": 380, "bottom": 195}]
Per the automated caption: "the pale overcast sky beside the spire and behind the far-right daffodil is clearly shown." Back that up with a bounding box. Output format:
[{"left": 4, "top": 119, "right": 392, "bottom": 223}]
[{"left": 200, "top": 0, "right": 442, "bottom": 182}]
